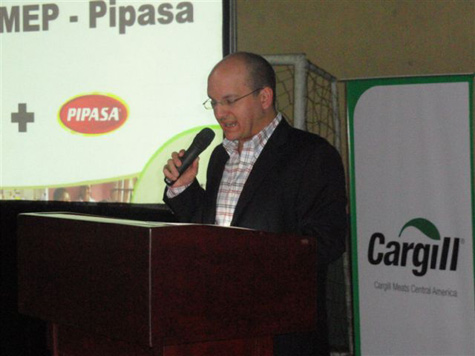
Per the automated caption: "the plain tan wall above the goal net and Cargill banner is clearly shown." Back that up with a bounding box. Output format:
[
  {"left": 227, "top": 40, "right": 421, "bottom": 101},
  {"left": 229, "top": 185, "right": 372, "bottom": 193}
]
[{"left": 236, "top": 0, "right": 475, "bottom": 160}]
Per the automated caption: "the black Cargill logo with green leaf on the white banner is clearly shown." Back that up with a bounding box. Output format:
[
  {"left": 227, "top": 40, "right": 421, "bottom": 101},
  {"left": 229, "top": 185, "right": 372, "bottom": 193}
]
[{"left": 368, "top": 218, "right": 460, "bottom": 277}]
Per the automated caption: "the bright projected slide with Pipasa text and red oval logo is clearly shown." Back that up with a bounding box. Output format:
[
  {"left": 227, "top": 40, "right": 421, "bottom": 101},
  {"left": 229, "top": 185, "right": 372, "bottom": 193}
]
[{"left": 0, "top": 0, "right": 223, "bottom": 203}]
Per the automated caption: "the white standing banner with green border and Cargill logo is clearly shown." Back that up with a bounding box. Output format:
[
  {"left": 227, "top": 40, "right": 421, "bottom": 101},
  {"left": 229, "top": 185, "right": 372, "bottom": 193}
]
[{"left": 347, "top": 76, "right": 475, "bottom": 355}]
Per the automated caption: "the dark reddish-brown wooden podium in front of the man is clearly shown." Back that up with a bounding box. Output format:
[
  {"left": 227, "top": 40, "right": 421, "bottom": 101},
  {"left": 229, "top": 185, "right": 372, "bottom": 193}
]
[{"left": 18, "top": 213, "right": 317, "bottom": 356}]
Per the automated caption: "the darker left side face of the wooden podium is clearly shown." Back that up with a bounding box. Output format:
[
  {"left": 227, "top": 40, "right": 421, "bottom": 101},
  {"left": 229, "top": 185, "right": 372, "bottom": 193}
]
[{"left": 18, "top": 214, "right": 151, "bottom": 345}]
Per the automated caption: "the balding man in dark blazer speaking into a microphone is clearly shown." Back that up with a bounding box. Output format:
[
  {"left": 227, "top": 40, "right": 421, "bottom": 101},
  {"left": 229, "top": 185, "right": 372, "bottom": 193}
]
[{"left": 163, "top": 52, "right": 347, "bottom": 356}]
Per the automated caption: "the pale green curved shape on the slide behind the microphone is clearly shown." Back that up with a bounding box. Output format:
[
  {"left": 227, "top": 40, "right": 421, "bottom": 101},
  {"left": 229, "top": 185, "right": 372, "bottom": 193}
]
[{"left": 132, "top": 125, "right": 223, "bottom": 204}]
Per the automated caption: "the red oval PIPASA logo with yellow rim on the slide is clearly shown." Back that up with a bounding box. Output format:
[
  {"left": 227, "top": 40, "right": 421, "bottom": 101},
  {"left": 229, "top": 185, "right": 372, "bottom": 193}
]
[{"left": 59, "top": 94, "right": 129, "bottom": 135}]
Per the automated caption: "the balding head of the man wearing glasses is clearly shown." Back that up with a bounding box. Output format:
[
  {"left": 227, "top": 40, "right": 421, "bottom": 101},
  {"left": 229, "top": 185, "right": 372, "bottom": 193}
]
[{"left": 208, "top": 52, "right": 277, "bottom": 148}]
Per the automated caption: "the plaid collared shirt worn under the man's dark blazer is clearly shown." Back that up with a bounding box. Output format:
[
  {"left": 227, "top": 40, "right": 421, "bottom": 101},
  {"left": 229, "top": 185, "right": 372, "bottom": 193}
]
[{"left": 216, "top": 113, "right": 282, "bottom": 226}]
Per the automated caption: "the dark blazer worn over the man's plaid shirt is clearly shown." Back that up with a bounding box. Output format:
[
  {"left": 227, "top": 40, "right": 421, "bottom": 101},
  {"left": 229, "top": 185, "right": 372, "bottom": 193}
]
[{"left": 164, "top": 119, "right": 347, "bottom": 264}]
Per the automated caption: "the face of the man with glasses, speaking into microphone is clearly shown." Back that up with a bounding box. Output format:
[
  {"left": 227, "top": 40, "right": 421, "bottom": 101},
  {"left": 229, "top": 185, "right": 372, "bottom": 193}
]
[{"left": 208, "top": 59, "right": 267, "bottom": 147}]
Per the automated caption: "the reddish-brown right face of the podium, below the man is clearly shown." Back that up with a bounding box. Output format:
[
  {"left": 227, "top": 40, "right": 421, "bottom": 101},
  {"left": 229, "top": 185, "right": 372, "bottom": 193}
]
[{"left": 152, "top": 225, "right": 317, "bottom": 344}]
